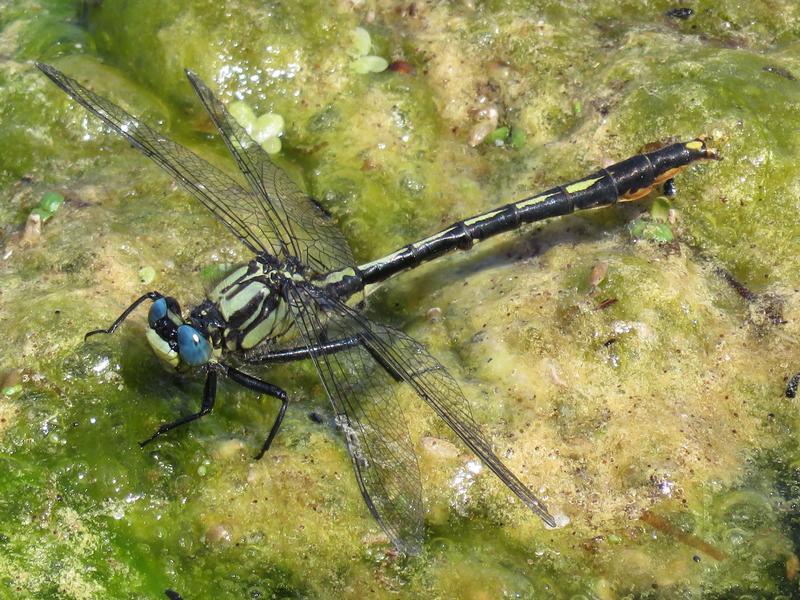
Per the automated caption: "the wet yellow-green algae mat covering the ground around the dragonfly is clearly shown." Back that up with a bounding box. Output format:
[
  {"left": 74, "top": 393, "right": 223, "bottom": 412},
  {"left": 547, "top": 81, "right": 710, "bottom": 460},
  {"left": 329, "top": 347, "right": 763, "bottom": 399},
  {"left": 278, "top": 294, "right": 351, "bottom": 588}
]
[{"left": 0, "top": 0, "right": 800, "bottom": 598}]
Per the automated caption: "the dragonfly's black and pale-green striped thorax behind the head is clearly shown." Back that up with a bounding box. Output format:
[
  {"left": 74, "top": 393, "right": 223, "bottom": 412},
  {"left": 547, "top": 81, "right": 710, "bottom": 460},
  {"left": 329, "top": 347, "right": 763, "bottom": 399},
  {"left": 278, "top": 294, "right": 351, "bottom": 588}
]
[{"left": 195, "top": 257, "right": 305, "bottom": 351}]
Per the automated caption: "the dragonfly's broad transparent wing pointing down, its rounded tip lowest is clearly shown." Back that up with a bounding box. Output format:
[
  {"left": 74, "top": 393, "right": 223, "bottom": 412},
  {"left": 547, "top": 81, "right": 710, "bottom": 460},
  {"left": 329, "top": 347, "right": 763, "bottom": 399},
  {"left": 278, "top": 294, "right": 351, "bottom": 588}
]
[{"left": 288, "top": 288, "right": 423, "bottom": 554}]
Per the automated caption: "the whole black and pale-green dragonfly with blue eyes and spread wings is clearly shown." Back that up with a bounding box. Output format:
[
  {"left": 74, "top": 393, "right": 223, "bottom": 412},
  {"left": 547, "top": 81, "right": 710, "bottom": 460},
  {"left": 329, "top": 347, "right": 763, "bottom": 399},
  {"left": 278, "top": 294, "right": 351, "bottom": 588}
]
[{"left": 37, "top": 63, "right": 717, "bottom": 554}]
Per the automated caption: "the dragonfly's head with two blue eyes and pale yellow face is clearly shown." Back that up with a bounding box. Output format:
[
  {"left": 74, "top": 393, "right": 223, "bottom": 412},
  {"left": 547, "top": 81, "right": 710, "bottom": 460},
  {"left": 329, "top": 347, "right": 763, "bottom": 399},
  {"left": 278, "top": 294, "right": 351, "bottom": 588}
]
[{"left": 147, "top": 296, "right": 212, "bottom": 369}]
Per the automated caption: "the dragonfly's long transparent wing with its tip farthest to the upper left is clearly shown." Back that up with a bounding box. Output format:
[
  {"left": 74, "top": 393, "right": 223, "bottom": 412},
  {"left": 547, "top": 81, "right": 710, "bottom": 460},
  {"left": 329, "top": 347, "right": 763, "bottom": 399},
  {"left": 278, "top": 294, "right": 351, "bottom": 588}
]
[{"left": 36, "top": 63, "right": 281, "bottom": 256}]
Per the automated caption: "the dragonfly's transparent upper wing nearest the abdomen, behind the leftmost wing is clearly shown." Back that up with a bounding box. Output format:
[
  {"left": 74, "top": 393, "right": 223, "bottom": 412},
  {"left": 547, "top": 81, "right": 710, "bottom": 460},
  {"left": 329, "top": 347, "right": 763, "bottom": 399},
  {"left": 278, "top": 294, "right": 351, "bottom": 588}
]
[{"left": 186, "top": 71, "right": 355, "bottom": 274}]
